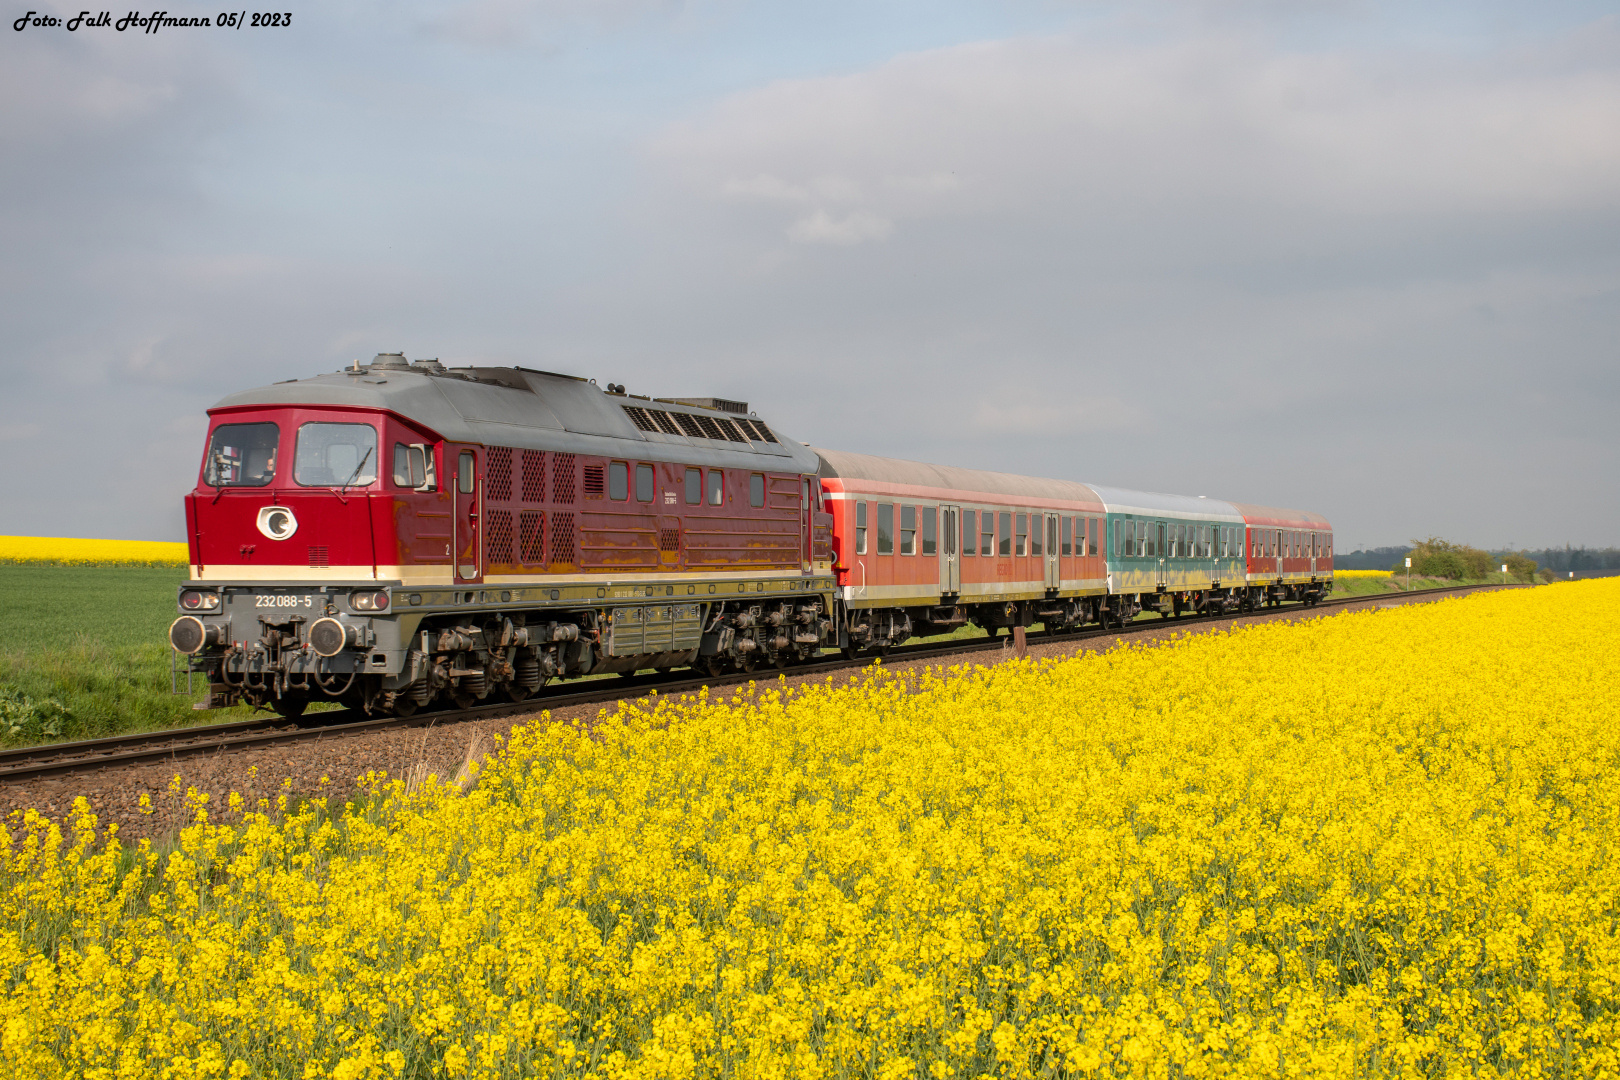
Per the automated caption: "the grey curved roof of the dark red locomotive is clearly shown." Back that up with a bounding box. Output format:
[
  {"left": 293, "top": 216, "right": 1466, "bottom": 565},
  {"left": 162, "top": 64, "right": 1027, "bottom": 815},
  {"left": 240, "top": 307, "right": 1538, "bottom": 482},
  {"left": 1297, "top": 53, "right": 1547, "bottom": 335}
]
[{"left": 209, "top": 355, "right": 818, "bottom": 473}]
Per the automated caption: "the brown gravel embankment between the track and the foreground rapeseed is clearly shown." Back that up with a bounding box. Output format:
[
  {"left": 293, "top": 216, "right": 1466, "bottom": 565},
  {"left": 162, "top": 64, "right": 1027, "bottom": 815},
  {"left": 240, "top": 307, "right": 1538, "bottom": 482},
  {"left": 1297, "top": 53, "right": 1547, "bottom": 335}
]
[{"left": 0, "top": 593, "right": 1503, "bottom": 842}]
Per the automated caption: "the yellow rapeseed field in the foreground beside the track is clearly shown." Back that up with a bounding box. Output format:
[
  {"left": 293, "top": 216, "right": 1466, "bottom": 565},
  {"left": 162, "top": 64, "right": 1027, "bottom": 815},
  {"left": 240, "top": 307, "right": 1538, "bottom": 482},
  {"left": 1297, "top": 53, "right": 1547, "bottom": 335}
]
[{"left": 0, "top": 581, "right": 1620, "bottom": 1078}]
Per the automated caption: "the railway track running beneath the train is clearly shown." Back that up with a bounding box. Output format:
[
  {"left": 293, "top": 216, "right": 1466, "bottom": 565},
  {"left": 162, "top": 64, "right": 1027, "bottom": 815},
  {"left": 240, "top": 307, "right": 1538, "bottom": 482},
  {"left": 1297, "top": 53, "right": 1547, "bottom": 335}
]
[{"left": 0, "top": 585, "right": 1528, "bottom": 782}]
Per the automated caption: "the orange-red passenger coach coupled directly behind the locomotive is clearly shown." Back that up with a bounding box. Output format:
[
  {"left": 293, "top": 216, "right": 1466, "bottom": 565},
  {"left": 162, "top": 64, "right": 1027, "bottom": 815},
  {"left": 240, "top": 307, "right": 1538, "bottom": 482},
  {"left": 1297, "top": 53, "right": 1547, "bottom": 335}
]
[{"left": 816, "top": 450, "right": 1108, "bottom": 649}]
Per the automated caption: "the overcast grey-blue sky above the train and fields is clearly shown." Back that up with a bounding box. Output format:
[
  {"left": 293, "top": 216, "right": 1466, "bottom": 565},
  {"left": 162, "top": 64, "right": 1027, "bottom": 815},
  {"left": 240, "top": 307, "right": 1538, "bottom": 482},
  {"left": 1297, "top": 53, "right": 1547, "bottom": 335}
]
[{"left": 0, "top": 0, "right": 1620, "bottom": 549}]
